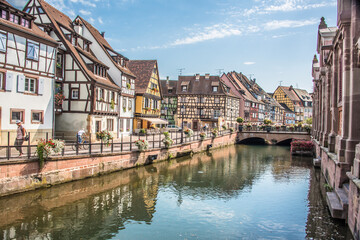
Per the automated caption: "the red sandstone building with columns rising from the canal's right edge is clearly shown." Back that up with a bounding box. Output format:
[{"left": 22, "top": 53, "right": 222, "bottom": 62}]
[{"left": 312, "top": 0, "right": 360, "bottom": 239}]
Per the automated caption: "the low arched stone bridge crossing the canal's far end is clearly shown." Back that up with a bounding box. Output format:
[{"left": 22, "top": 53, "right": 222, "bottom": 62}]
[{"left": 236, "top": 131, "right": 310, "bottom": 144}]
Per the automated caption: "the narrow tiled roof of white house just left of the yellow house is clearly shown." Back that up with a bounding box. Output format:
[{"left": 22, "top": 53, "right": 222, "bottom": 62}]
[{"left": 78, "top": 16, "right": 135, "bottom": 77}]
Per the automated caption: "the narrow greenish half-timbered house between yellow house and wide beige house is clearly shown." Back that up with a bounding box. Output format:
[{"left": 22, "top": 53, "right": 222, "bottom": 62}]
[{"left": 160, "top": 77, "right": 178, "bottom": 125}]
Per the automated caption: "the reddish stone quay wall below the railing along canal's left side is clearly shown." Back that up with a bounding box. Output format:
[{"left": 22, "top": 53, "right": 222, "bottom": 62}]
[{"left": 0, "top": 133, "right": 237, "bottom": 196}]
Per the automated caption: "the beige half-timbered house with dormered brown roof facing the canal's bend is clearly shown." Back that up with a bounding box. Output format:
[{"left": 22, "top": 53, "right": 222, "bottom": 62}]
[{"left": 176, "top": 74, "right": 239, "bottom": 130}]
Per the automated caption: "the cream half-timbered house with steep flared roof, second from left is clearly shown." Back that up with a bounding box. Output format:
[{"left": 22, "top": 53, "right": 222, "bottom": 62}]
[{"left": 24, "top": 0, "right": 120, "bottom": 138}]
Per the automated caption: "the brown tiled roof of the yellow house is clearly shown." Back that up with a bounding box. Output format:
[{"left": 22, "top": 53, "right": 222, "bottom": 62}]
[{"left": 128, "top": 60, "right": 157, "bottom": 94}]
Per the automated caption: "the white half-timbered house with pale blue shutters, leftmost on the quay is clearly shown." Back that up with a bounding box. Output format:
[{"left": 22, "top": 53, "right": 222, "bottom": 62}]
[{"left": 0, "top": 0, "right": 58, "bottom": 144}]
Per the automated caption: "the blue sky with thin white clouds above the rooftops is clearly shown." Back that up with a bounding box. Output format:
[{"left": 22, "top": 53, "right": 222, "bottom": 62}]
[{"left": 8, "top": 0, "right": 337, "bottom": 92}]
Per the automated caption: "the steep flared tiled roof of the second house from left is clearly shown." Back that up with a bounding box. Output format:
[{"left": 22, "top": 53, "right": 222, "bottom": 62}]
[{"left": 38, "top": 0, "right": 120, "bottom": 89}]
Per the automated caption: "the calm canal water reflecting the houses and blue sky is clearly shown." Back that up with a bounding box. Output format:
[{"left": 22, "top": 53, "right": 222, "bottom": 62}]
[{"left": 0, "top": 145, "right": 351, "bottom": 239}]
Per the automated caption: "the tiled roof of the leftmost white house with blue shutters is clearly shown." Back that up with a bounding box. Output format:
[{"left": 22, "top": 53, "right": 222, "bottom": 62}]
[{"left": 0, "top": 0, "right": 58, "bottom": 45}]
